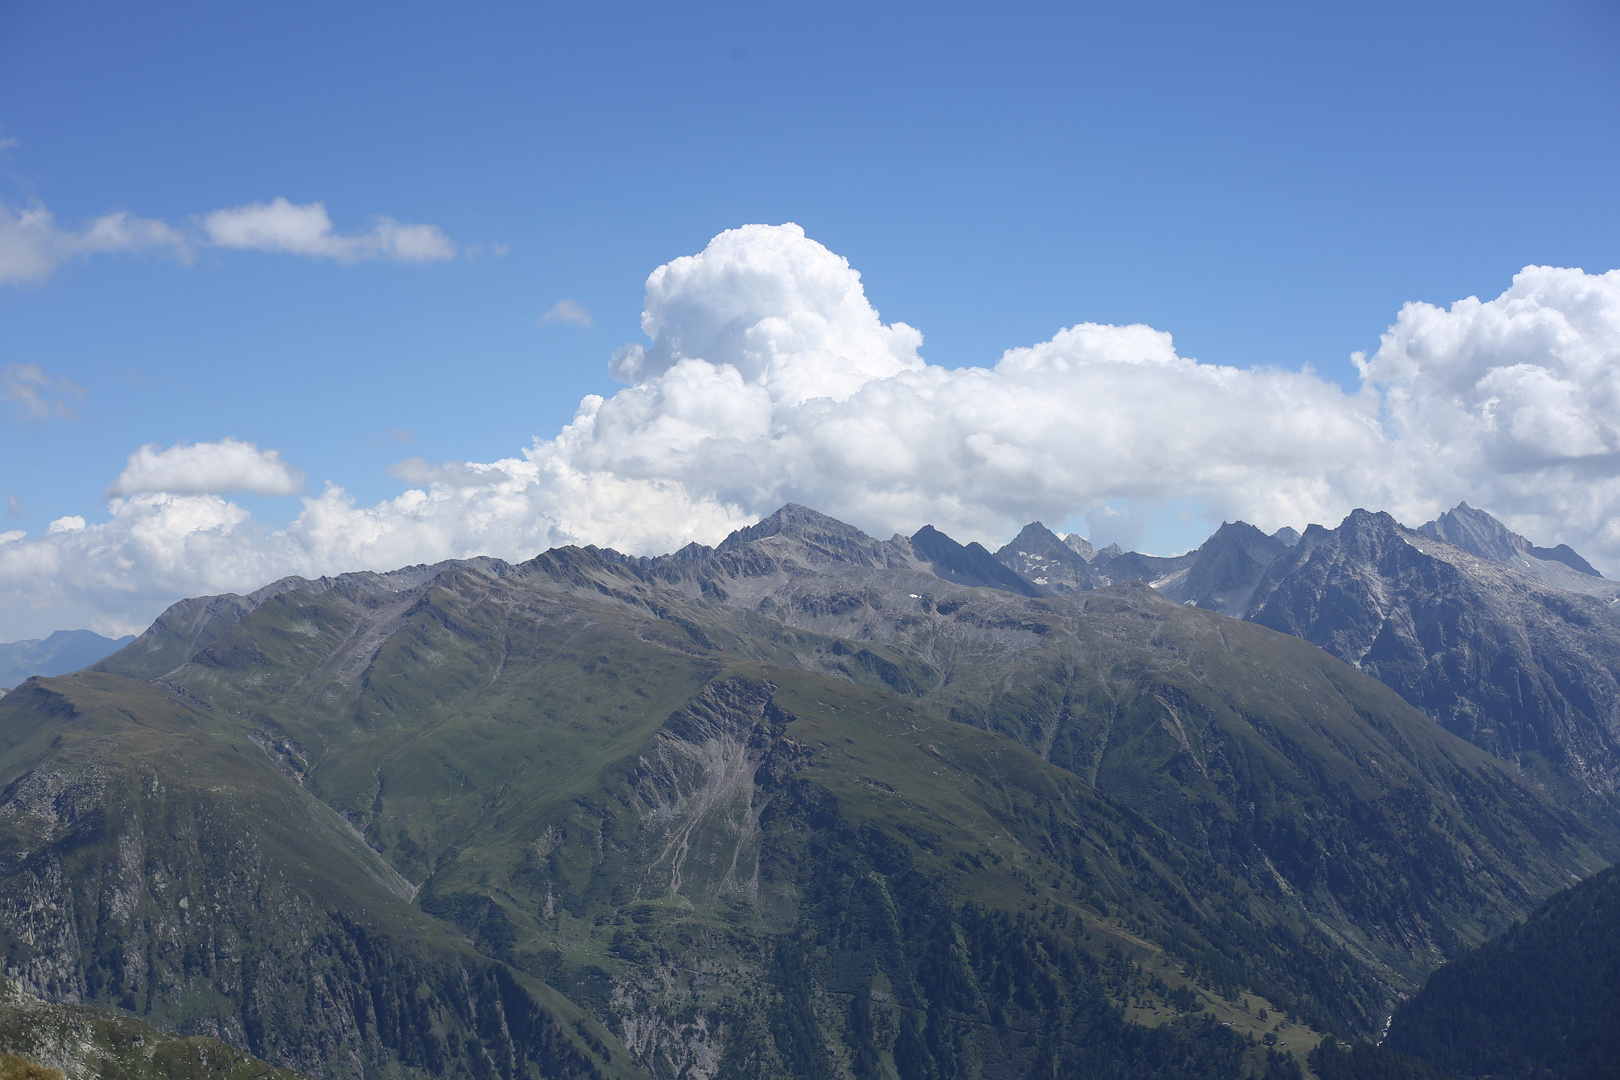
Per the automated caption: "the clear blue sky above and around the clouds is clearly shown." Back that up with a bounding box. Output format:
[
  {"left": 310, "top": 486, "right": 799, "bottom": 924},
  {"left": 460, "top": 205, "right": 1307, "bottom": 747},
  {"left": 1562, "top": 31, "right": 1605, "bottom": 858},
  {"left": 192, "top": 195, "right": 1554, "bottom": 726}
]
[{"left": 0, "top": 2, "right": 1620, "bottom": 636}]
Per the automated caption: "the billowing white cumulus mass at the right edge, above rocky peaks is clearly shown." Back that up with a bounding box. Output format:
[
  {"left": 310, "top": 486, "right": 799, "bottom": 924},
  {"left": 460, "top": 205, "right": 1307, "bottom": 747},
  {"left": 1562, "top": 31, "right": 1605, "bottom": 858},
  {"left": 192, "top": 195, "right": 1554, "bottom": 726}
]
[{"left": 1356, "top": 266, "right": 1620, "bottom": 557}]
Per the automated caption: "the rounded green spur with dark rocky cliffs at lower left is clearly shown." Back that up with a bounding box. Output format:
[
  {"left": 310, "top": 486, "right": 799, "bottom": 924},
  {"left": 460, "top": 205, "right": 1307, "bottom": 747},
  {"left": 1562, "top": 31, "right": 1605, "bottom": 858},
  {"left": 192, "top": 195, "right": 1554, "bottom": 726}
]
[{"left": 0, "top": 674, "right": 633, "bottom": 1077}]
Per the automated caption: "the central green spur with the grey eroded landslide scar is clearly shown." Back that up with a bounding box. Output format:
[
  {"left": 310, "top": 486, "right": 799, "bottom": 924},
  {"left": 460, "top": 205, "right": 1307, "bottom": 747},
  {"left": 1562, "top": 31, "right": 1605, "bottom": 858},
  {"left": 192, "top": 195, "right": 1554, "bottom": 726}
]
[{"left": 91, "top": 575, "right": 1354, "bottom": 1075}]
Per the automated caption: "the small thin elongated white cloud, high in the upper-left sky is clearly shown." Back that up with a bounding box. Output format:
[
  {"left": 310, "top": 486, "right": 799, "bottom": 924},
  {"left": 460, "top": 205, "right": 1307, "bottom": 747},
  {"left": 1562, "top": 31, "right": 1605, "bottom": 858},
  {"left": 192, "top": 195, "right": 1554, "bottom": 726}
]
[{"left": 201, "top": 198, "right": 455, "bottom": 262}]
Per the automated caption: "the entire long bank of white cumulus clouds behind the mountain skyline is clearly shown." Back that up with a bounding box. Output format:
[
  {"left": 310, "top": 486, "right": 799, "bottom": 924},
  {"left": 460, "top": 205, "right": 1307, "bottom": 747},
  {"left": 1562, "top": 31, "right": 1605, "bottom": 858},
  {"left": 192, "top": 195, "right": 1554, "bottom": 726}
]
[{"left": 0, "top": 225, "right": 1620, "bottom": 636}]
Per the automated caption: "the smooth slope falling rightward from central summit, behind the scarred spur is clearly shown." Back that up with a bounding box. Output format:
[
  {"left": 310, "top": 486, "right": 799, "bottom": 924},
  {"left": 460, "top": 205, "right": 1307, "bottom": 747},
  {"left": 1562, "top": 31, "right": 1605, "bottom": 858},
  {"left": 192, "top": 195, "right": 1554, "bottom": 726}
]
[{"left": 635, "top": 534, "right": 1615, "bottom": 986}]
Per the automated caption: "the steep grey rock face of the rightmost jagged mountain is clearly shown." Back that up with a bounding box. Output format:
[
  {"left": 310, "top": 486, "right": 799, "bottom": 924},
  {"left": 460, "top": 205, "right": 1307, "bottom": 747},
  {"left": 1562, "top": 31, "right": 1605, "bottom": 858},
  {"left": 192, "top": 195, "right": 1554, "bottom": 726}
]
[{"left": 1246, "top": 510, "right": 1620, "bottom": 793}]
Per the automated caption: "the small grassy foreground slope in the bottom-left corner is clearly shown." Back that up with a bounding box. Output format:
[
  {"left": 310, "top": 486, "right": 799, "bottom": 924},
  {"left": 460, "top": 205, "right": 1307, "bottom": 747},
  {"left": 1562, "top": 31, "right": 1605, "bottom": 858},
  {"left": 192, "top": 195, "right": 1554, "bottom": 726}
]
[{"left": 0, "top": 980, "right": 301, "bottom": 1080}]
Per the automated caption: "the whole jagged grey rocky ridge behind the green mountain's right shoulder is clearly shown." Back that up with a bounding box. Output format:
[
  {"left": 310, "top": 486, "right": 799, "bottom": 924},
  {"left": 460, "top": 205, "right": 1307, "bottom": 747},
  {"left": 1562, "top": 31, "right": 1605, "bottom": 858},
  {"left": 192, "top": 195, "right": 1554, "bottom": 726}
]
[{"left": 996, "top": 504, "right": 1620, "bottom": 800}]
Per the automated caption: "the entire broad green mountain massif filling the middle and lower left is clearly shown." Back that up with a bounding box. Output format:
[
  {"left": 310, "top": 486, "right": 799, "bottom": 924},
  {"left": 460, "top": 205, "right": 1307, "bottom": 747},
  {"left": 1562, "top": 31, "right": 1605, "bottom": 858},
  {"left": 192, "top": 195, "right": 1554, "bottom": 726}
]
[{"left": 0, "top": 507, "right": 1615, "bottom": 1080}]
